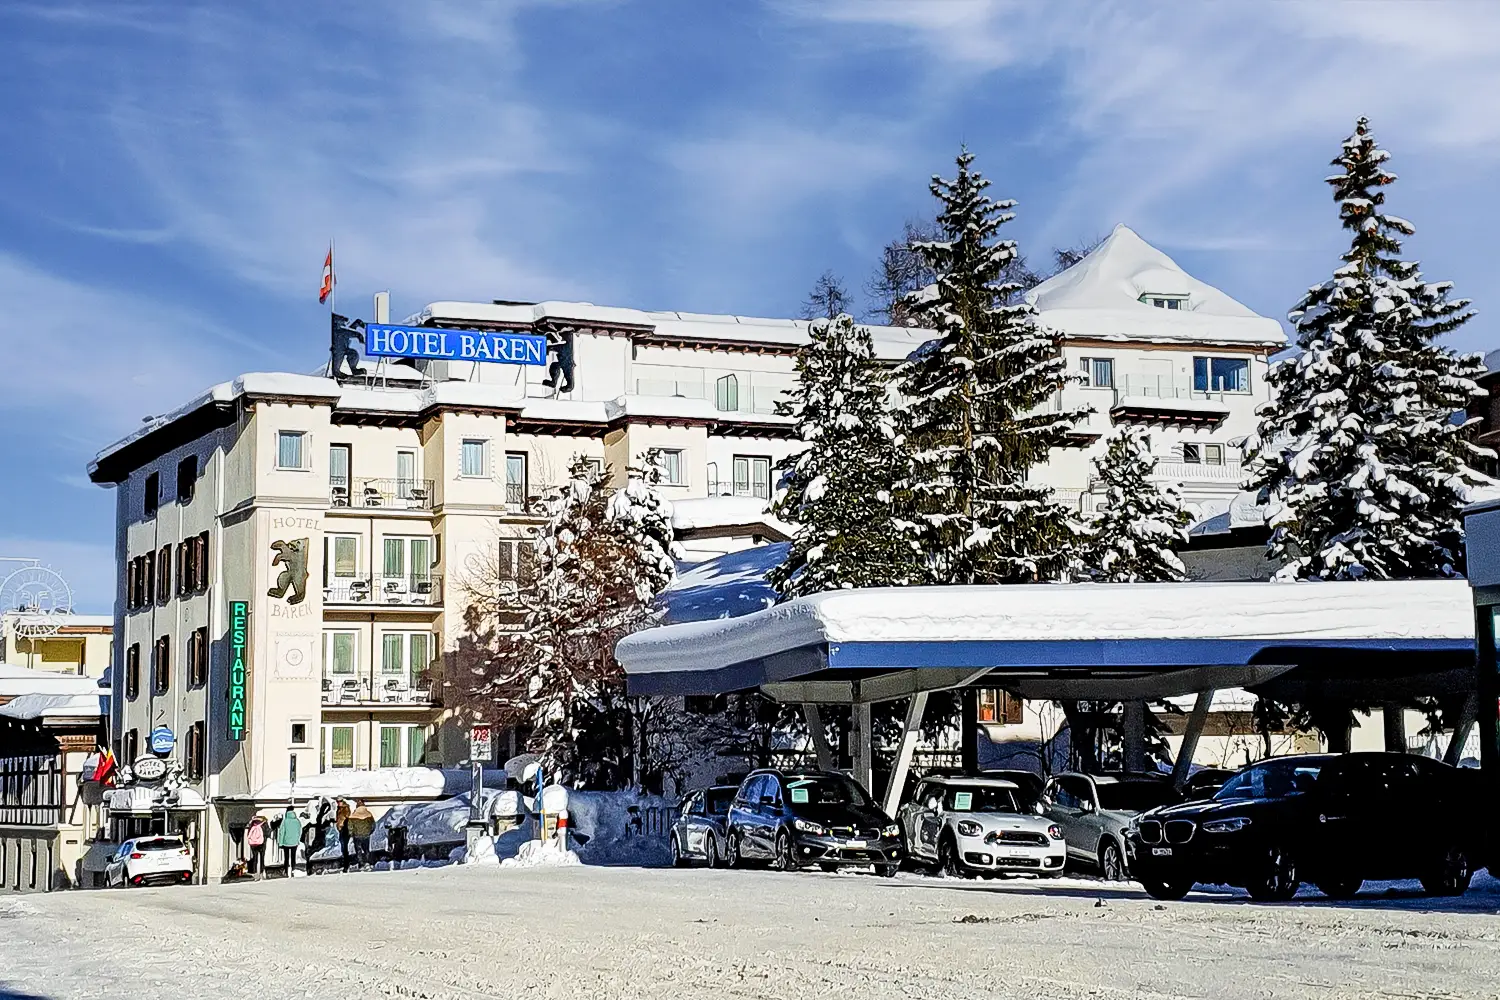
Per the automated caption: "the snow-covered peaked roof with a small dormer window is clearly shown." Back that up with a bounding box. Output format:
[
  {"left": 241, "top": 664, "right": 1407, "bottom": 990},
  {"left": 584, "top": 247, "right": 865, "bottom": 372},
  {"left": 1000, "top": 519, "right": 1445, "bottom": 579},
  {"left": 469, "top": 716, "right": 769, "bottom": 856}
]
[{"left": 1026, "top": 225, "right": 1287, "bottom": 348}]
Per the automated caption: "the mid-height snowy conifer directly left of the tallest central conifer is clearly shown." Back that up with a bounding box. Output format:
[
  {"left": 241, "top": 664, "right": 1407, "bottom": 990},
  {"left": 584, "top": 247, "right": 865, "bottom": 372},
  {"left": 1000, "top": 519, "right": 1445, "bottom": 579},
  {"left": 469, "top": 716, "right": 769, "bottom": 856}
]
[{"left": 770, "top": 315, "right": 917, "bottom": 598}]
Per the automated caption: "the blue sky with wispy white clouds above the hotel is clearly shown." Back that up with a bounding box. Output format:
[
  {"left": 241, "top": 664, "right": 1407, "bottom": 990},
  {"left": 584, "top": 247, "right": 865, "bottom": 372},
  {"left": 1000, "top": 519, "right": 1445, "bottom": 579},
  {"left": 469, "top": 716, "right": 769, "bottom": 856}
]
[{"left": 0, "top": 0, "right": 1500, "bottom": 612}]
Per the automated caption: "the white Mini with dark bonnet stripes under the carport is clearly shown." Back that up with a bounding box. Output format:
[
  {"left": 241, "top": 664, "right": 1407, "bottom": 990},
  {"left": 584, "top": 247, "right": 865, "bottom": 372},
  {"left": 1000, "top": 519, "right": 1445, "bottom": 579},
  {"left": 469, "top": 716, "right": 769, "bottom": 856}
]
[{"left": 896, "top": 775, "right": 1067, "bottom": 876}]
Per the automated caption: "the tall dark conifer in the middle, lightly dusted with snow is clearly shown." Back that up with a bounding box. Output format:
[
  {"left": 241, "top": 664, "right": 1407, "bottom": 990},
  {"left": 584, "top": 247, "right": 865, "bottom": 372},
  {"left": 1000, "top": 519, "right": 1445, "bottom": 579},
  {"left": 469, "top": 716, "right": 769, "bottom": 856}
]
[{"left": 896, "top": 150, "right": 1086, "bottom": 583}]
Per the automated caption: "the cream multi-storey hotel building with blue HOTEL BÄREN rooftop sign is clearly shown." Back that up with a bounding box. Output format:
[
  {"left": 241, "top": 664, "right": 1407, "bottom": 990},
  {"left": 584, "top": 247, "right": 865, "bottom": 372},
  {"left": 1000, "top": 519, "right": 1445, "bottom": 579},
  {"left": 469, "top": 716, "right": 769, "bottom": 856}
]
[{"left": 89, "top": 226, "right": 1286, "bottom": 877}]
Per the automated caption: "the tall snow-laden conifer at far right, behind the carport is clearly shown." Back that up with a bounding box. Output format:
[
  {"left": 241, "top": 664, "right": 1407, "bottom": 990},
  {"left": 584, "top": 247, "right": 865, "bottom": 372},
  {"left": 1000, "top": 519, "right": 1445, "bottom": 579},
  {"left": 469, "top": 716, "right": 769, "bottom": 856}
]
[{"left": 1251, "top": 118, "right": 1490, "bottom": 580}]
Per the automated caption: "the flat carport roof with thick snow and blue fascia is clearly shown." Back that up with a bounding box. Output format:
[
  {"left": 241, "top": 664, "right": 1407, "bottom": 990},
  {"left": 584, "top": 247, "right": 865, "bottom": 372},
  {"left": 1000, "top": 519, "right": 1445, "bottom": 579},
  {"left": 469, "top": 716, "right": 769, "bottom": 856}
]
[{"left": 615, "top": 580, "right": 1475, "bottom": 694}]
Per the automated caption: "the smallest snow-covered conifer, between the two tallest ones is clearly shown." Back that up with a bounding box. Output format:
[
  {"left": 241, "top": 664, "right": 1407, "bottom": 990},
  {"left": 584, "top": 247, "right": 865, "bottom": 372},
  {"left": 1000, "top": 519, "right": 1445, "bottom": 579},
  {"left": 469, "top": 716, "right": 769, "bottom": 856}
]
[{"left": 1082, "top": 426, "right": 1191, "bottom": 583}]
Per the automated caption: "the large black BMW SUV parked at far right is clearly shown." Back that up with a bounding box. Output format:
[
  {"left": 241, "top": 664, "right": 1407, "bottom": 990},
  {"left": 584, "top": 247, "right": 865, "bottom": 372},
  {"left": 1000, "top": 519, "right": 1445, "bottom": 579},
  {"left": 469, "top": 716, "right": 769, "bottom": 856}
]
[{"left": 1130, "top": 753, "right": 1481, "bottom": 900}]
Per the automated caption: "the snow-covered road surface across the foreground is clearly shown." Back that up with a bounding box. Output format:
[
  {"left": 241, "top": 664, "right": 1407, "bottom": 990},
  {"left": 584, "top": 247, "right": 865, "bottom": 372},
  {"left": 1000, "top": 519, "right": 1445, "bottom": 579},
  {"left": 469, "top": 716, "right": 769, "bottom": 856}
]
[{"left": 0, "top": 868, "right": 1500, "bottom": 1000}]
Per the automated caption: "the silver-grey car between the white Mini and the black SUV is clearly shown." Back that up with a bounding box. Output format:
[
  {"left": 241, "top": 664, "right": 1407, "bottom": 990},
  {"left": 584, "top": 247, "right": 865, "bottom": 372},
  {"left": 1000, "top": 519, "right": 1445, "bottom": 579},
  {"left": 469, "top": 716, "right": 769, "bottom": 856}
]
[{"left": 1038, "top": 774, "right": 1182, "bottom": 880}]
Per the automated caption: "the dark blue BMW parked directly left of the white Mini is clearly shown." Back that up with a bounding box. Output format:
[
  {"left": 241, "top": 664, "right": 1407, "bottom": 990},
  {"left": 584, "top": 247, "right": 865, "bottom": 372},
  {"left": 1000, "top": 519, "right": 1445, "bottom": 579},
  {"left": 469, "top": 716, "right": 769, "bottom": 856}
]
[{"left": 725, "top": 771, "right": 903, "bottom": 876}]
